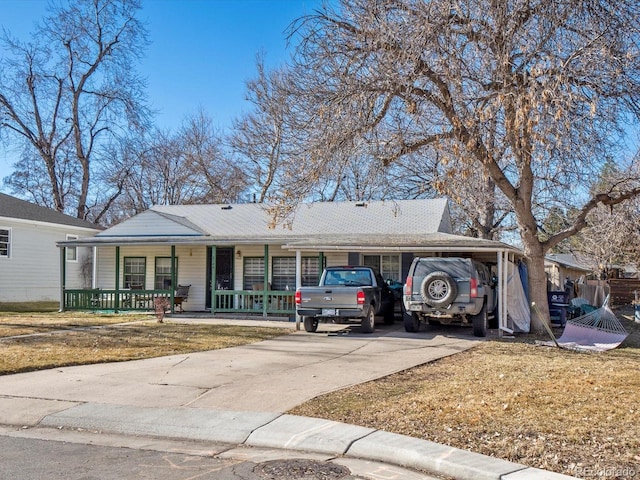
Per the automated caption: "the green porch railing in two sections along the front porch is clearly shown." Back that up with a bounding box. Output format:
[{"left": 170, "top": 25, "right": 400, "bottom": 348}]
[{"left": 64, "top": 289, "right": 295, "bottom": 315}]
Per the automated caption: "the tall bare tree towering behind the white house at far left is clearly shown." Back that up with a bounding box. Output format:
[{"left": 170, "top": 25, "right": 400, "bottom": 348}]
[{"left": 0, "top": 0, "right": 147, "bottom": 218}]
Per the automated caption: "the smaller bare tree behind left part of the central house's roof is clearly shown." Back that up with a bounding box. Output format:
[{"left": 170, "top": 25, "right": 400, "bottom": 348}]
[{"left": 99, "top": 111, "right": 246, "bottom": 220}]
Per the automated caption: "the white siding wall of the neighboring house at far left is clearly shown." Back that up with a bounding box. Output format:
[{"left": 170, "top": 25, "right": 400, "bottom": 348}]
[{"left": 0, "top": 219, "right": 97, "bottom": 302}]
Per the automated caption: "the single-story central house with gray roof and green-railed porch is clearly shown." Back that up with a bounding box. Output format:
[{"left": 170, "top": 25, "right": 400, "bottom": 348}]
[{"left": 59, "top": 199, "right": 517, "bottom": 324}]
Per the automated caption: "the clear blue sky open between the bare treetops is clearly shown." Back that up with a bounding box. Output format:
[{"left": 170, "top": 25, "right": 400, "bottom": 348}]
[{"left": 0, "top": 0, "right": 321, "bottom": 182}]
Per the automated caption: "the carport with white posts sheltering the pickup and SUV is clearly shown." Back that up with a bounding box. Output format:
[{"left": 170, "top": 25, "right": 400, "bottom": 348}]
[{"left": 283, "top": 233, "right": 524, "bottom": 335}]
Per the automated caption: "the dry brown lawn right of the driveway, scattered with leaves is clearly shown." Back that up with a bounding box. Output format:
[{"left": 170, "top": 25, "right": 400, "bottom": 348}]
[{"left": 289, "top": 310, "right": 640, "bottom": 478}]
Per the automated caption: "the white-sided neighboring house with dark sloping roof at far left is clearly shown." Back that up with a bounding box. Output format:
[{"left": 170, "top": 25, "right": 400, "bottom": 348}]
[{"left": 0, "top": 193, "right": 101, "bottom": 302}]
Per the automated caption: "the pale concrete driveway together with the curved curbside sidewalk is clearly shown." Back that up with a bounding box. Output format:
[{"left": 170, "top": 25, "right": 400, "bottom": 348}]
[{"left": 0, "top": 318, "right": 571, "bottom": 480}]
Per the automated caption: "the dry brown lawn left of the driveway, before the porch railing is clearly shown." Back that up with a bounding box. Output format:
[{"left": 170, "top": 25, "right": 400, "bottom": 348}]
[{"left": 0, "top": 313, "right": 288, "bottom": 375}]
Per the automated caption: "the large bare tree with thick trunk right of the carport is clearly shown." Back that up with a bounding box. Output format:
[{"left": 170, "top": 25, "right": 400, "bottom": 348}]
[{"left": 284, "top": 0, "right": 640, "bottom": 331}]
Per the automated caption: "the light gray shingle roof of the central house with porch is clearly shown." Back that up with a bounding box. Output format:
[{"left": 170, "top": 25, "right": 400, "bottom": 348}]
[{"left": 59, "top": 199, "right": 516, "bottom": 259}]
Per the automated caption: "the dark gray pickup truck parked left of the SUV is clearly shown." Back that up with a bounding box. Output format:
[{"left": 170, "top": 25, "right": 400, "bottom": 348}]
[{"left": 295, "top": 266, "right": 395, "bottom": 333}]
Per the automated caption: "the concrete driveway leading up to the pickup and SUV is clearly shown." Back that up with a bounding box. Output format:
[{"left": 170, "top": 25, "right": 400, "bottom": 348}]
[{"left": 0, "top": 319, "right": 478, "bottom": 416}]
